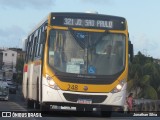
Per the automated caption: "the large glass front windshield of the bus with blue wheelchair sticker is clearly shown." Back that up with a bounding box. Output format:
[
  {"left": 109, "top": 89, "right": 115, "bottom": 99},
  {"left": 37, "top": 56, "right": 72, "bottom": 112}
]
[{"left": 48, "top": 29, "right": 126, "bottom": 75}]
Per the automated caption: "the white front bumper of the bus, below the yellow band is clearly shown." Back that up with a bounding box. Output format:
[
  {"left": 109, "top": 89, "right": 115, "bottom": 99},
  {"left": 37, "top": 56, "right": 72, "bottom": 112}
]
[{"left": 42, "top": 83, "right": 126, "bottom": 107}]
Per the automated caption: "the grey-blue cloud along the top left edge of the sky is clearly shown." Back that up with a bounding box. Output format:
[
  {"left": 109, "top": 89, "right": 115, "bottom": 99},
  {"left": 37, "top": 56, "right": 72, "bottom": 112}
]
[{"left": 0, "top": 0, "right": 55, "bottom": 10}]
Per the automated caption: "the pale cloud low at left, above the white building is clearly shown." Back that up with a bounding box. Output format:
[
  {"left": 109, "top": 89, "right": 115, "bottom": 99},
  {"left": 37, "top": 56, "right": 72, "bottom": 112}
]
[{"left": 0, "top": 25, "right": 26, "bottom": 47}]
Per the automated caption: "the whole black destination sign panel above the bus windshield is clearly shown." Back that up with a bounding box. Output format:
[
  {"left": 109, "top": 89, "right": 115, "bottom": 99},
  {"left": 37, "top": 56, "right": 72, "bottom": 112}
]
[{"left": 51, "top": 13, "right": 126, "bottom": 30}]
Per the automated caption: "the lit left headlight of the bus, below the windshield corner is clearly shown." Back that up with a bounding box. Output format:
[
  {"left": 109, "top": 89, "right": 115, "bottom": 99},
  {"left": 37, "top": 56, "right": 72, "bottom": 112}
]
[{"left": 46, "top": 75, "right": 60, "bottom": 90}]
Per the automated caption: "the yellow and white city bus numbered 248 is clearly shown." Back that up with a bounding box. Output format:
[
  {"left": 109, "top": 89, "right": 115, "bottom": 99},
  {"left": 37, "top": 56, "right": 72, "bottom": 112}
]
[{"left": 22, "top": 12, "right": 133, "bottom": 114}]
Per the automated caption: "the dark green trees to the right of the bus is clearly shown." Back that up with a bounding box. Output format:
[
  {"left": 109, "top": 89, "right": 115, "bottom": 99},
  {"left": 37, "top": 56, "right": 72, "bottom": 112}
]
[{"left": 128, "top": 52, "right": 160, "bottom": 99}]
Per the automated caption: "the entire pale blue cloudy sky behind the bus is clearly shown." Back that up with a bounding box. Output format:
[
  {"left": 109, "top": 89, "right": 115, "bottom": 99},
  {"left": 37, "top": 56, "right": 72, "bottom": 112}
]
[{"left": 0, "top": 0, "right": 160, "bottom": 59}]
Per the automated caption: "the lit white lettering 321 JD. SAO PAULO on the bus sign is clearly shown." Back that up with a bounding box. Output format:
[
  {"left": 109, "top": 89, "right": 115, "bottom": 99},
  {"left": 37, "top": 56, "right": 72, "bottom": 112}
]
[{"left": 63, "top": 18, "right": 113, "bottom": 29}]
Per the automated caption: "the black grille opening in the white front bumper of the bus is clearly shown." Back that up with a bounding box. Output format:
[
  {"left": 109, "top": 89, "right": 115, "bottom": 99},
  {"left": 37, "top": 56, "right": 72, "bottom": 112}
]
[{"left": 63, "top": 93, "right": 107, "bottom": 103}]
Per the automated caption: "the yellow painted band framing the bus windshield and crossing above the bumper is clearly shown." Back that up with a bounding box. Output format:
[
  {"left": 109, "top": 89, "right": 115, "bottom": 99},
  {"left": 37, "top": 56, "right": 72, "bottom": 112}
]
[{"left": 26, "top": 13, "right": 128, "bottom": 93}]
